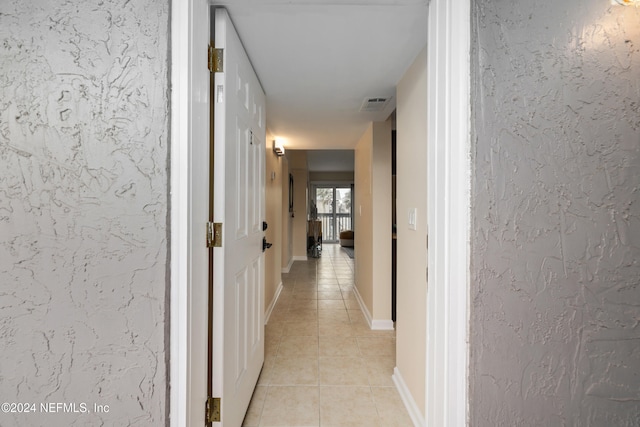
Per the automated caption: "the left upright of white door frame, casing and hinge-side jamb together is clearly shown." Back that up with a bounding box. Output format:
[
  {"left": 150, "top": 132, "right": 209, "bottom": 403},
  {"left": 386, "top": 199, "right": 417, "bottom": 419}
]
[{"left": 168, "top": 0, "right": 209, "bottom": 427}]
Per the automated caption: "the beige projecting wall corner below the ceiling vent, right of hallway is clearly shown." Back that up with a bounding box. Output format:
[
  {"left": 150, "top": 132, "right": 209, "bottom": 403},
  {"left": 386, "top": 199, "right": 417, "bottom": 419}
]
[{"left": 354, "top": 121, "right": 391, "bottom": 320}]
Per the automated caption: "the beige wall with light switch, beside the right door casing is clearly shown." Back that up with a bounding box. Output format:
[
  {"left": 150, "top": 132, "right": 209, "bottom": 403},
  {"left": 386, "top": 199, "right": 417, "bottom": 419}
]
[{"left": 396, "top": 47, "right": 427, "bottom": 415}]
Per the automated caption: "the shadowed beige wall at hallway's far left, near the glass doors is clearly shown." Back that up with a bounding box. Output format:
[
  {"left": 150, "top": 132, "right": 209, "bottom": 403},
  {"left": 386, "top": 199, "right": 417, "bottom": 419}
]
[{"left": 287, "top": 150, "right": 309, "bottom": 259}]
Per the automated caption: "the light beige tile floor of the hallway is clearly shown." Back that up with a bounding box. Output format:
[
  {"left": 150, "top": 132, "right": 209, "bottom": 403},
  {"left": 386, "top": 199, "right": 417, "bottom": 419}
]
[{"left": 243, "top": 244, "right": 413, "bottom": 427}]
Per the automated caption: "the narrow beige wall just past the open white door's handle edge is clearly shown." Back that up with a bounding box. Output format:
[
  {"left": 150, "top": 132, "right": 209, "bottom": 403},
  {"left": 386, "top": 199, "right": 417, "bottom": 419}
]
[{"left": 264, "top": 133, "right": 288, "bottom": 316}]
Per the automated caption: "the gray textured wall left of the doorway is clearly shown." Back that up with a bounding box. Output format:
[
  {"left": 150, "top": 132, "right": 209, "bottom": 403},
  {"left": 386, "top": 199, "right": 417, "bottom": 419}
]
[{"left": 0, "top": 0, "right": 169, "bottom": 426}]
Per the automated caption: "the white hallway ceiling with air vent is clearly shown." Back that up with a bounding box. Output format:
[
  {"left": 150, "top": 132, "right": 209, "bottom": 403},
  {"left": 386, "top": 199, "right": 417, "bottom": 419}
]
[{"left": 216, "top": 0, "right": 428, "bottom": 149}]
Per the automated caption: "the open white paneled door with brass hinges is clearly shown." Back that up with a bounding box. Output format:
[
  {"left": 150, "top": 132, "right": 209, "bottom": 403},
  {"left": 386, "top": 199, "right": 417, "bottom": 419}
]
[{"left": 210, "top": 8, "right": 266, "bottom": 427}]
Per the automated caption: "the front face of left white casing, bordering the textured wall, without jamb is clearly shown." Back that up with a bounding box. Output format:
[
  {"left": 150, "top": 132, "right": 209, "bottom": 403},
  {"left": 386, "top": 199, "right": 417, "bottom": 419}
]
[{"left": 167, "top": 0, "right": 191, "bottom": 427}]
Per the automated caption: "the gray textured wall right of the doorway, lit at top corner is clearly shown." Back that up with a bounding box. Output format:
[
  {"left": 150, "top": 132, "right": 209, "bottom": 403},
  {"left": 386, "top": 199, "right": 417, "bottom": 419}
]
[{"left": 469, "top": 0, "right": 640, "bottom": 426}]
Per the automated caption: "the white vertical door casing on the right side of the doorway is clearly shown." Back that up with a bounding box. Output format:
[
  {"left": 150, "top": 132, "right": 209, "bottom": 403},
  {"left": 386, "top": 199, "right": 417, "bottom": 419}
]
[{"left": 425, "top": 0, "right": 471, "bottom": 427}]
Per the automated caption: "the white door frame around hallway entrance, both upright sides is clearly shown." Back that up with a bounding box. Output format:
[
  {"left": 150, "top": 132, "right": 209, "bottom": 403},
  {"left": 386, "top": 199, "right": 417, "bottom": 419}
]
[{"left": 165, "top": 0, "right": 470, "bottom": 427}]
